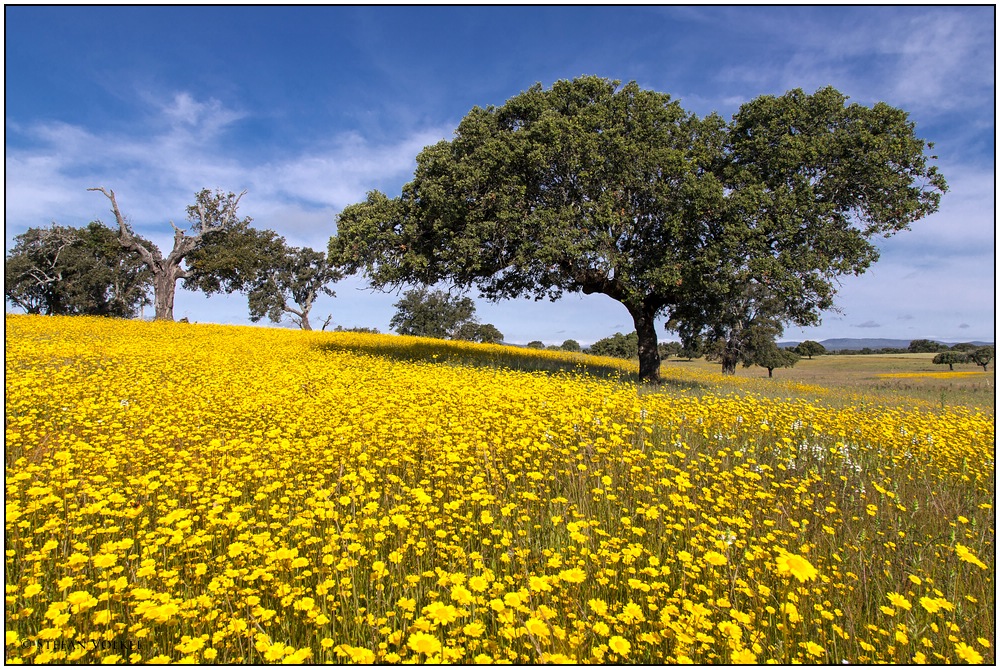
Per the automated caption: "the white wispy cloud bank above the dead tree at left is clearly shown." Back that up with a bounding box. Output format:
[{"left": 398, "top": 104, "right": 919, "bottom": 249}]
[{"left": 5, "top": 92, "right": 451, "bottom": 253}]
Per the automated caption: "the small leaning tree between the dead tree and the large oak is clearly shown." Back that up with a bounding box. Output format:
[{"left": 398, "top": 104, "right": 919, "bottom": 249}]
[{"left": 247, "top": 245, "right": 343, "bottom": 330}]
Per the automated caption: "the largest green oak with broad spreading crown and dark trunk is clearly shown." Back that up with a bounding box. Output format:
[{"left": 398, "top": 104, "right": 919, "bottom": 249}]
[{"left": 330, "top": 77, "right": 946, "bottom": 380}]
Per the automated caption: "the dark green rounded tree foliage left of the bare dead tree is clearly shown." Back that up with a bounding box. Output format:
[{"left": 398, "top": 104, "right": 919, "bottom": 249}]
[{"left": 4, "top": 221, "right": 151, "bottom": 318}]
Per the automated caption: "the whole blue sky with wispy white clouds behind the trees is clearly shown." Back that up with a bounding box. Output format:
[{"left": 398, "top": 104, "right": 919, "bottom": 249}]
[{"left": 4, "top": 6, "right": 996, "bottom": 344}]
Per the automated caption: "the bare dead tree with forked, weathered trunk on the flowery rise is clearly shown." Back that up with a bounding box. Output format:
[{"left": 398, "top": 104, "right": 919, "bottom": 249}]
[{"left": 87, "top": 187, "right": 246, "bottom": 321}]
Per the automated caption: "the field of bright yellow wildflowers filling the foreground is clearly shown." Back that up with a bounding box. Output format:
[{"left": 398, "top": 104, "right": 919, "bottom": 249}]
[{"left": 4, "top": 316, "right": 996, "bottom": 664}]
